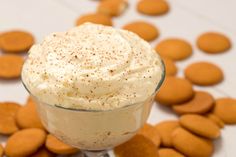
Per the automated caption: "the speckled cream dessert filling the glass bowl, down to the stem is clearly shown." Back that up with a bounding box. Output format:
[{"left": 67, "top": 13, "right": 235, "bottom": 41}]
[{"left": 22, "top": 23, "right": 164, "bottom": 150}]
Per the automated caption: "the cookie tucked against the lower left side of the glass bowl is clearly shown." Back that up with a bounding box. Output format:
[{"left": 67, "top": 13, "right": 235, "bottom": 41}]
[{"left": 45, "top": 134, "right": 79, "bottom": 155}]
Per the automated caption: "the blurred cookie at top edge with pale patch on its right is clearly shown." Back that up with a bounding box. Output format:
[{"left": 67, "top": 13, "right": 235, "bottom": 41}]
[{"left": 97, "top": 0, "right": 128, "bottom": 16}]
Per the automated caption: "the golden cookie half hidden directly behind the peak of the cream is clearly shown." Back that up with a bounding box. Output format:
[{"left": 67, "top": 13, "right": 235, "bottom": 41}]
[{"left": 76, "top": 13, "right": 112, "bottom": 26}]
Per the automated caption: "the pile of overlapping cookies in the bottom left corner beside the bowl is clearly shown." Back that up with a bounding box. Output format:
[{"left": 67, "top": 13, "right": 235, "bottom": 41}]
[{"left": 0, "top": 98, "right": 79, "bottom": 157}]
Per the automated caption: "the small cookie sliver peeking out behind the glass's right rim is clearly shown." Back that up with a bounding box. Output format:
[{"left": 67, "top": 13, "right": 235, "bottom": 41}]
[{"left": 162, "top": 57, "right": 178, "bottom": 76}]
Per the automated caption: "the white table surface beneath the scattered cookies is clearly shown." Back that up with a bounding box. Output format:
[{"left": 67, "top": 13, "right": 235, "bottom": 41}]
[{"left": 0, "top": 0, "right": 236, "bottom": 157}]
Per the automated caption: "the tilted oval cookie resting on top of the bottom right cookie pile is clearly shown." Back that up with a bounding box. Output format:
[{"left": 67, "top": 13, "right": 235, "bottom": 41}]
[{"left": 179, "top": 114, "right": 220, "bottom": 139}]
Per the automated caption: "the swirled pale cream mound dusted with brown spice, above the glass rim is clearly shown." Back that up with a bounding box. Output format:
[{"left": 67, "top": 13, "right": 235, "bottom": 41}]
[{"left": 22, "top": 23, "right": 163, "bottom": 110}]
